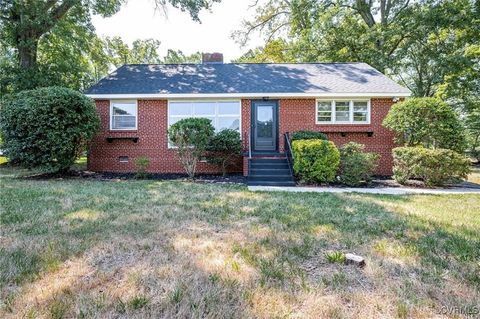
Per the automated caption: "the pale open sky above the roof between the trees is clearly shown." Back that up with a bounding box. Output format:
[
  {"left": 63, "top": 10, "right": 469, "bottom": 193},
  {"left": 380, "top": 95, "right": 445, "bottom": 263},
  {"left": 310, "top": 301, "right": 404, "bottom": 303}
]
[{"left": 93, "top": 0, "right": 263, "bottom": 62}]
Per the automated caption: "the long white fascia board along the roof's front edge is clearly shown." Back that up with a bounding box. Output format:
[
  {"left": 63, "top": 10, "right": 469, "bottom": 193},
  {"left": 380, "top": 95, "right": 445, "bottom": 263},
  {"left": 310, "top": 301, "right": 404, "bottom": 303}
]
[{"left": 86, "top": 92, "right": 411, "bottom": 100}]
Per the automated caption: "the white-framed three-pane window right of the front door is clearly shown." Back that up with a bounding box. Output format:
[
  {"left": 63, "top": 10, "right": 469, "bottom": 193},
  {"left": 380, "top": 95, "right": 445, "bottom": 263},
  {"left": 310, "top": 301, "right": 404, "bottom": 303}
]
[{"left": 316, "top": 100, "right": 370, "bottom": 124}]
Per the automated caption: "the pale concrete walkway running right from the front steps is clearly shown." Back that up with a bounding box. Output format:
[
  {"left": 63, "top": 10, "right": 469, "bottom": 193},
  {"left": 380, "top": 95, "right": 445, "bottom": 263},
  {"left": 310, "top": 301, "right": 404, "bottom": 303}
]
[{"left": 248, "top": 186, "right": 480, "bottom": 195}]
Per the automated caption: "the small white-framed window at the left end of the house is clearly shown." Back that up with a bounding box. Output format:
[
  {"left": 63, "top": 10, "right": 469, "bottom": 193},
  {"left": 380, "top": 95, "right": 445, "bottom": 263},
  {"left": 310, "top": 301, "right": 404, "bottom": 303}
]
[{"left": 110, "top": 101, "right": 138, "bottom": 130}]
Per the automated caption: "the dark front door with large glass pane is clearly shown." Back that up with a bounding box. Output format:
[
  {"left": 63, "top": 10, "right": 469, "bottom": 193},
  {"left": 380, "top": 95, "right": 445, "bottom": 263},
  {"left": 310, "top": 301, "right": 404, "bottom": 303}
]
[{"left": 252, "top": 101, "right": 278, "bottom": 152}]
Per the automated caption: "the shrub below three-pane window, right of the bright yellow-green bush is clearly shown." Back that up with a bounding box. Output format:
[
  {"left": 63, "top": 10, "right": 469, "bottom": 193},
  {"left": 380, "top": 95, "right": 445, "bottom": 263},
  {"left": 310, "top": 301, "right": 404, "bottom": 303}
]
[{"left": 340, "top": 142, "right": 380, "bottom": 186}]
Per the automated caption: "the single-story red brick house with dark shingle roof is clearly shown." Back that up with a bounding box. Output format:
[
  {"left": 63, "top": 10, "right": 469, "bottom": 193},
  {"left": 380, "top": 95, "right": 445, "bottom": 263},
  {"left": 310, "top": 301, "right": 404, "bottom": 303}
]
[{"left": 85, "top": 54, "right": 410, "bottom": 185}]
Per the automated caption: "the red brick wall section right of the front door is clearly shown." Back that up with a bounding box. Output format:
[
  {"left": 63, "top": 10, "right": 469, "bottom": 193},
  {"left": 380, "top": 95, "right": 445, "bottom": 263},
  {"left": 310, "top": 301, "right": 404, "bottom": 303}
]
[{"left": 279, "top": 99, "right": 394, "bottom": 175}]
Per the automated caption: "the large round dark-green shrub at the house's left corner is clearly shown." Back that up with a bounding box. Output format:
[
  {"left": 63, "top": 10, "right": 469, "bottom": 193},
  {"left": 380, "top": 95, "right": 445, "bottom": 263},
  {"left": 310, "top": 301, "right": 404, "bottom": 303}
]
[{"left": 0, "top": 87, "right": 99, "bottom": 172}]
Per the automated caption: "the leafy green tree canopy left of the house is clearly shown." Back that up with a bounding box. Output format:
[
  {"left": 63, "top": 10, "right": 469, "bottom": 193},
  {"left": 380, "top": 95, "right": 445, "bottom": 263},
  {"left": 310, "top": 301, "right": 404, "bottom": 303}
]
[{"left": 0, "top": 0, "right": 219, "bottom": 92}]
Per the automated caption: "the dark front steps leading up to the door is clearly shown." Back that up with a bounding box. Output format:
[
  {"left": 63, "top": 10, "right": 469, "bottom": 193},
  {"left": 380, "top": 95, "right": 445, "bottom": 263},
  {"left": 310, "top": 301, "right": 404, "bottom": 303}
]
[{"left": 247, "top": 156, "right": 295, "bottom": 186}]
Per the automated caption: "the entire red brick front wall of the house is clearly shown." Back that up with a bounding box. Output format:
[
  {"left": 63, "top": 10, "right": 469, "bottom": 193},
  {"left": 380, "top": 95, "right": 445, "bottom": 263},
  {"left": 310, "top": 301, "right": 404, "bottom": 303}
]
[{"left": 88, "top": 99, "right": 394, "bottom": 175}]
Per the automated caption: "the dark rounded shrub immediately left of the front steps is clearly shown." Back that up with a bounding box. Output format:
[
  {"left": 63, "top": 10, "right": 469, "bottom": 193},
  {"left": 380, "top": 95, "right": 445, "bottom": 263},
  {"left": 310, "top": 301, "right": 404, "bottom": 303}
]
[{"left": 207, "top": 129, "right": 242, "bottom": 176}]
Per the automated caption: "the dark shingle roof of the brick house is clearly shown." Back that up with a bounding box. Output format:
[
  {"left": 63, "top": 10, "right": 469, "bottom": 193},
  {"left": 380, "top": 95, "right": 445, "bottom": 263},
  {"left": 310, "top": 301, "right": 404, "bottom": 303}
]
[{"left": 85, "top": 63, "right": 410, "bottom": 95}]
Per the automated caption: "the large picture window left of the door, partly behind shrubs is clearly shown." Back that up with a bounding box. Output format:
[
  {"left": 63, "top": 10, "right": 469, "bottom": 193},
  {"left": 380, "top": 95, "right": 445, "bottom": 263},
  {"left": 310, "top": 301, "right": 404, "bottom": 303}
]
[{"left": 168, "top": 101, "right": 241, "bottom": 132}]
